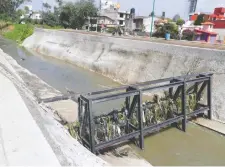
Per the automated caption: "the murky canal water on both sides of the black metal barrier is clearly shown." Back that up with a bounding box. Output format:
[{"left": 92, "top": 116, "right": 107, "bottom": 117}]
[{"left": 0, "top": 39, "right": 225, "bottom": 165}]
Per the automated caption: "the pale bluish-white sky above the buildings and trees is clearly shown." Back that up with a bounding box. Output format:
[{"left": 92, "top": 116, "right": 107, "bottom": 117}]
[{"left": 25, "top": 0, "right": 225, "bottom": 19}]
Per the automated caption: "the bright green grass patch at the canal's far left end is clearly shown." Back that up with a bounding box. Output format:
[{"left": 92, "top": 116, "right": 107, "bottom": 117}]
[{"left": 3, "top": 24, "right": 34, "bottom": 44}]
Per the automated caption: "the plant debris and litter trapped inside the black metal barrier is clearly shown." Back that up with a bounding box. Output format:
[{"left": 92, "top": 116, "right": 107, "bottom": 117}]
[{"left": 69, "top": 92, "right": 197, "bottom": 144}]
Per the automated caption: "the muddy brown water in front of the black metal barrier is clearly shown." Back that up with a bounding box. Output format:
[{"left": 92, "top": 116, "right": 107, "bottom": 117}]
[{"left": 132, "top": 123, "right": 225, "bottom": 166}]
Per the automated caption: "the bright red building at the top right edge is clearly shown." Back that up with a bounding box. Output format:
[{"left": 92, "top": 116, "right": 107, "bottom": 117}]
[{"left": 189, "top": 7, "right": 225, "bottom": 29}]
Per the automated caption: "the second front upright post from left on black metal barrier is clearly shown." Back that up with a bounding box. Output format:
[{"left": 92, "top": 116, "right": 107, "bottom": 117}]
[{"left": 138, "top": 91, "right": 144, "bottom": 150}]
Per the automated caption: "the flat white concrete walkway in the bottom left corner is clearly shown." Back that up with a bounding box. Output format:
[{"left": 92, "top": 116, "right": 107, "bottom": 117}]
[{"left": 0, "top": 74, "right": 60, "bottom": 166}]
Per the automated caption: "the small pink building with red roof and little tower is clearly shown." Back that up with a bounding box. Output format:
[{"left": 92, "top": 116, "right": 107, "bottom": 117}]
[{"left": 194, "top": 22, "right": 217, "bottom": 44}]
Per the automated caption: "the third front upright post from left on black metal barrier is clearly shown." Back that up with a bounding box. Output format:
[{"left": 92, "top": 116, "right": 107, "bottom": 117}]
[{"left": 182, "top": 81, "right": 187, "bottom": 132}]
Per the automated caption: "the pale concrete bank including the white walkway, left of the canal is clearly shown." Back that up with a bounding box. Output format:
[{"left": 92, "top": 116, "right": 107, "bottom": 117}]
[{"left": 0, "top": 49, "right": 109, "bottom": 166}]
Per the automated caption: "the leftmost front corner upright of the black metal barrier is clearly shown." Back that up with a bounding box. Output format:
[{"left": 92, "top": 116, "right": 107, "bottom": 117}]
[{"left": 88, "top": 100, "right": 95, "bottom": 153}]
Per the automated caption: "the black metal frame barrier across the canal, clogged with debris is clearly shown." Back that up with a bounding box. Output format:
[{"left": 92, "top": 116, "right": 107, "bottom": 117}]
[{"left": 78, "top": 74, "right": 212, "bottom": 153}]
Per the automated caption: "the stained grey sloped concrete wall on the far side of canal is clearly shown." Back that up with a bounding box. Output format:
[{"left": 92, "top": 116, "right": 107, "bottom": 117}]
[{"left": 23, "top": 29, "right": 225, "bottom": 121}]
